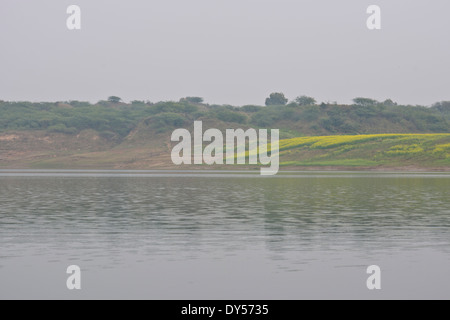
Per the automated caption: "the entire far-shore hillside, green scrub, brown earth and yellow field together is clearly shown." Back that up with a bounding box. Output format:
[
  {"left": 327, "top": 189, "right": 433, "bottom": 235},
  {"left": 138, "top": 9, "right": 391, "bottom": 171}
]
[{"left": 0, "top": 99, "right": 450, "bottom": 170}]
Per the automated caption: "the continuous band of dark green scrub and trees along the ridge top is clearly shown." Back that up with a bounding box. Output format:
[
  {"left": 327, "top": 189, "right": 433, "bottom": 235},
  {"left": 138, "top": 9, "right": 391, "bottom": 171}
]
[{"left": 0, "top": 98, "right": 450, "bottom": 140}]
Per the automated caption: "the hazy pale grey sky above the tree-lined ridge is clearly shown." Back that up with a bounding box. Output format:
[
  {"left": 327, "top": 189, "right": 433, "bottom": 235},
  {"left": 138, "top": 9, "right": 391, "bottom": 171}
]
[{"left": 0, "top": 0, "right": 450, "bottom": 105}]
